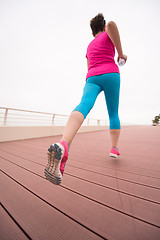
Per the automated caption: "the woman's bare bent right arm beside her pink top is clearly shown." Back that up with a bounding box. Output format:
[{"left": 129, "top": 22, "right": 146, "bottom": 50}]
[{"left": 106, "top": 21, "right": 127, "bottom": 61}]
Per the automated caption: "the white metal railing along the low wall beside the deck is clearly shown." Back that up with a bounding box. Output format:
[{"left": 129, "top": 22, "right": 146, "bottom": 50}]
[{"left": 0, "top": 107, "right": 107, "bottom": 126}]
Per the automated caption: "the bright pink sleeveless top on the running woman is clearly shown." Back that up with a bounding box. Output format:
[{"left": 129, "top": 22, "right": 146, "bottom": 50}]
[{"left": 86, "top": 32, "right": 119, "bottom": 79}]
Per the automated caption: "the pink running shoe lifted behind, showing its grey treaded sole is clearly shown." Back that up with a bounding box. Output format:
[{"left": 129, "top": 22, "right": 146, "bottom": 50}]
[{"left": 44, "top": 140, "right": 68, "bottom": 185}]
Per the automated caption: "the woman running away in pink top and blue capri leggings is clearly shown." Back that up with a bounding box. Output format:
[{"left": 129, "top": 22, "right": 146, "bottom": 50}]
[{"left": 44, "top": 13, "right": 127, "bottom": 185}]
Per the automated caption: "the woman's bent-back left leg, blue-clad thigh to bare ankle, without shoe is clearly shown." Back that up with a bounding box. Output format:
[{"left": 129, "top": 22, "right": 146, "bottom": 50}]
[{"left": 62, "top": 82, "right": 102, "bottom": 145}]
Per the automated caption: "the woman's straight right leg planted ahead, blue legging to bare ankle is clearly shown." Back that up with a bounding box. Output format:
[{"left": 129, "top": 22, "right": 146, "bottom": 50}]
[{"left": 103, "top": 73, "right": 121, "bottom": 148}]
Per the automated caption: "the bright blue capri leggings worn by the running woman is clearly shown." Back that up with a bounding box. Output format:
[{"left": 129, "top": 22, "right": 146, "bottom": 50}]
[{"left": 73, "top": 73, "right": 121, "bottom": 129}]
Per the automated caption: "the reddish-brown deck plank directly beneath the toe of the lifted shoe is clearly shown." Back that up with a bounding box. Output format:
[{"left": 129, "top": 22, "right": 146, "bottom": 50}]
[{"left": 0, "top": 158, "right": 160, "bottom": 240}]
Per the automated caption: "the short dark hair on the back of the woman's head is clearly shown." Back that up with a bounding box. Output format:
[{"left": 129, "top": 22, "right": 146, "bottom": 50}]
[{"left": 90, "top": 13, "right": 106, "bottom": 37}]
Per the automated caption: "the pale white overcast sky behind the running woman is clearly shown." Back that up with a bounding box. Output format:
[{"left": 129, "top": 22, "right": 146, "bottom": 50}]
[{"left": 0, "top": 0, "right": 160, "bottom": 124}]
